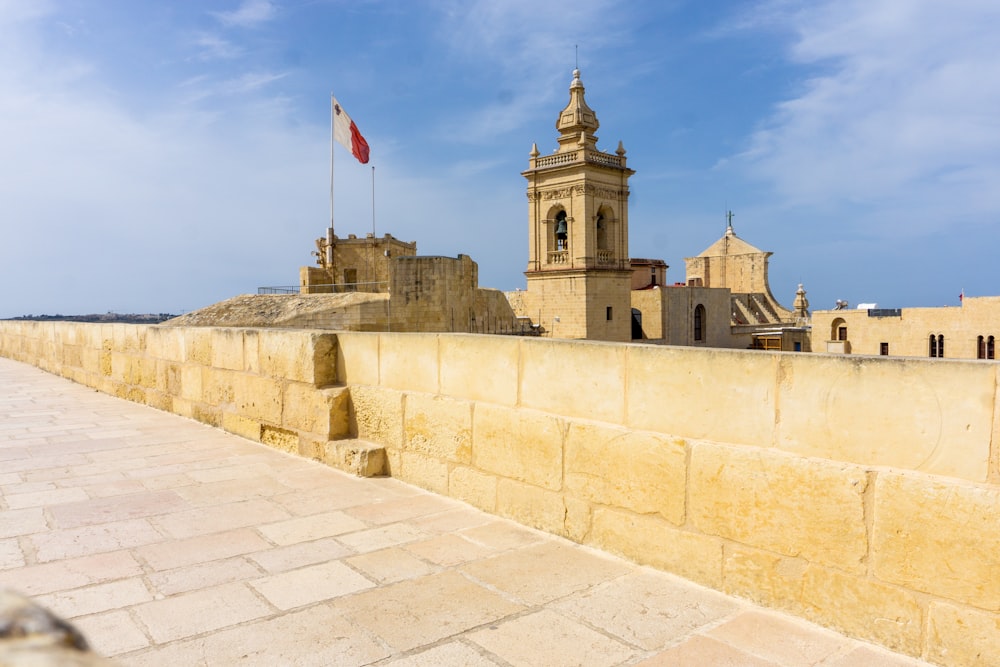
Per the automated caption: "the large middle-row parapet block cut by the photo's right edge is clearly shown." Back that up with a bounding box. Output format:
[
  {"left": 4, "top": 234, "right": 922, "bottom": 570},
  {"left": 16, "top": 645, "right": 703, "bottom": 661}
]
[{"left": 872, "top": 472, "right": 1000, "bottom": 611}]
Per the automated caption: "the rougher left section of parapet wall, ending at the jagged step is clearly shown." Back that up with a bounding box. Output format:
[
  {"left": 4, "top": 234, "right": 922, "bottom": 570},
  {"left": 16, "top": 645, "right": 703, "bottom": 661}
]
[{"left": 0, "top": 321, "right": 349, "bottom": 459}]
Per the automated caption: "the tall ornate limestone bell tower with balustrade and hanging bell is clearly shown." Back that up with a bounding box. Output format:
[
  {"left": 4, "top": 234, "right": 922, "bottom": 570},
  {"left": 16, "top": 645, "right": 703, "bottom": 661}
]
[{"left": 522, "top": 70, "right": 635, "bottom": 341}]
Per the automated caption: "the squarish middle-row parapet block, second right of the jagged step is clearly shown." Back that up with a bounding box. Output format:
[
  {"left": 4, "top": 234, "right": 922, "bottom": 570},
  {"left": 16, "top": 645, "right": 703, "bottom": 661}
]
[{"left": 403, "top": 393, "right": 472, "bottom": 464}]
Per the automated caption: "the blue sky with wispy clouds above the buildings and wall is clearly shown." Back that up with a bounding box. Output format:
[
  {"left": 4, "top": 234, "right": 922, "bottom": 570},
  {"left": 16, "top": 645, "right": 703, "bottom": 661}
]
[{"left": 0, "top": 0, "right": 1000, "bottom": 317}]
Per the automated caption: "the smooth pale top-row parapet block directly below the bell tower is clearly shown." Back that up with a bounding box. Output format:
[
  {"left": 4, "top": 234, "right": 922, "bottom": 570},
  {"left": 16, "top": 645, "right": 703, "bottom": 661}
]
[{"left": 520, "top": 340, "right": 625, "bottom": 424}]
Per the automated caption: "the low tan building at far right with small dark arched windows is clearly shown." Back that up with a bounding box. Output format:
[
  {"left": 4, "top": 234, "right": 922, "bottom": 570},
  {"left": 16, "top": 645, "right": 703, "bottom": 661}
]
[{"left": 812, "top": 296, "right": 1000, "bottom": 359}]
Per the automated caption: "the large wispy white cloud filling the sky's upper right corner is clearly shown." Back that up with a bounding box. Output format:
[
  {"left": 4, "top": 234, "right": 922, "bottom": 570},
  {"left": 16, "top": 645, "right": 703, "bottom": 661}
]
[{"left": 741, "top": 0, "right": 1000, "bottom": 232}]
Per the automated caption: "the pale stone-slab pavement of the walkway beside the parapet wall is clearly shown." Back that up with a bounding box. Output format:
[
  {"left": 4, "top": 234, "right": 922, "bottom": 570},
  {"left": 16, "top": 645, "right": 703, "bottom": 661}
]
[{"left": 0, "top": 359, "right": 927, "bottom": 667}]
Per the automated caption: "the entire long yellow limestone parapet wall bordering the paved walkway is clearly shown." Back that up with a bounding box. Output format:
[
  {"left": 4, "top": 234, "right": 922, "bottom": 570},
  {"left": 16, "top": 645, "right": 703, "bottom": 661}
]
[{"left": 0, "top": 322, "right": 1000, "bottom": 665}]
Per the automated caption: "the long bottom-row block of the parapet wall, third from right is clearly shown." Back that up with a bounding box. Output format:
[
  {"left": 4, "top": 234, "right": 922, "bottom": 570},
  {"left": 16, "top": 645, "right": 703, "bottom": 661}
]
[{"left": 587, "top": 508, "right": 722, "bottom": 588}]
